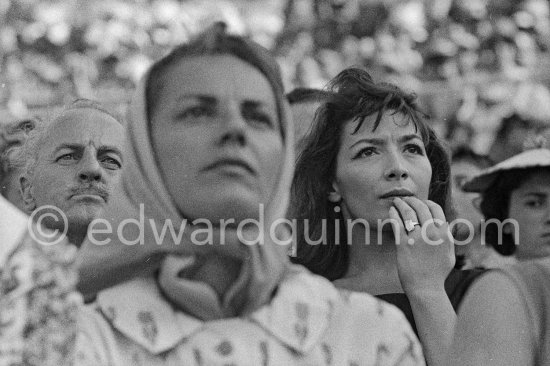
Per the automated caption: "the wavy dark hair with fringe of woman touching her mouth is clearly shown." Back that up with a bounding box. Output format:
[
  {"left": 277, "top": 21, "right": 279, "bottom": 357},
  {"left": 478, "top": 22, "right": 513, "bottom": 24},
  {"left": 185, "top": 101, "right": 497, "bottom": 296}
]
[{"left": 290, "top": 68, "right": 452, "bottom": 280}]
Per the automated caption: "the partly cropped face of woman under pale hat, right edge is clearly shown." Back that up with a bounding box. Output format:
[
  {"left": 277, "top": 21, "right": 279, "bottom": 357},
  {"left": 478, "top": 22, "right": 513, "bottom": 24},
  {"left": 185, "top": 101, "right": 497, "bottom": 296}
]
[{"left": 503, "top": 171, "right": 550, "bottom": 260}]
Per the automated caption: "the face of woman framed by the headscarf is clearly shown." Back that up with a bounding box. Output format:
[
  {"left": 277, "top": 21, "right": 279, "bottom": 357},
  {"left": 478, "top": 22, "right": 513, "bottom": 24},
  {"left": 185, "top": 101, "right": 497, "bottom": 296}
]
[{"left": 150, "top": 55, "right": 283, "bottom": 224}]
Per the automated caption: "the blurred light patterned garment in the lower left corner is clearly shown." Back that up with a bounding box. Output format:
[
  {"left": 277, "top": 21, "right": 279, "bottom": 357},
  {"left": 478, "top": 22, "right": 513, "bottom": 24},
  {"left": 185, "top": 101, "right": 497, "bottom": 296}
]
[{"left": 0, "top": 197, "right": 82, "bottom": 366}]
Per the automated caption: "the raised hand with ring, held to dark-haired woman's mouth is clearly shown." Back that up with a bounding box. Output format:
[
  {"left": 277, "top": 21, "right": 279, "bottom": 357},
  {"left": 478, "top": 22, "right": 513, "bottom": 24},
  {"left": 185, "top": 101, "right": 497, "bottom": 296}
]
[{"left": 389, "top": 197, "right": 455, "bottom": 295}]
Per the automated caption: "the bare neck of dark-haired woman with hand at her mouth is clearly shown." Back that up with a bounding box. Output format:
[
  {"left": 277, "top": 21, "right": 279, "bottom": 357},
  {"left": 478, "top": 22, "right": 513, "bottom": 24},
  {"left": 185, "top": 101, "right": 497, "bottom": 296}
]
[{"left": 334, "top": 227, "right": 403, "bottom": 295}]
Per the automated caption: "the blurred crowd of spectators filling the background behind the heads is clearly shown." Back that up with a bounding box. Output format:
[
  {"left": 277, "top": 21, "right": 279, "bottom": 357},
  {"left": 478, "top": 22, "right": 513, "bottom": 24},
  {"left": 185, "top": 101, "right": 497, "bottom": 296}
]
[{"left": 0, "top": 0, "right": 550, "bottom": 153}]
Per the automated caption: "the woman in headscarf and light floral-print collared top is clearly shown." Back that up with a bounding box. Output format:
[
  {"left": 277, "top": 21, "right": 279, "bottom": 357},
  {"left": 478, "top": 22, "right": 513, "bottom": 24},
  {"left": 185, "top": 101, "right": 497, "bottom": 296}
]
[{"left": 77, "top": 26, "right": 424, "bottom": 366}]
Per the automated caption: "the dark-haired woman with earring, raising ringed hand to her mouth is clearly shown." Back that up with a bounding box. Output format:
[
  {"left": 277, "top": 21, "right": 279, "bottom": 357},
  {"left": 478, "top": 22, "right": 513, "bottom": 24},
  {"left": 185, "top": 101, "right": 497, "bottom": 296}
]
[{"left": 290, "top": 68, "right": 484, "bottom": 365}]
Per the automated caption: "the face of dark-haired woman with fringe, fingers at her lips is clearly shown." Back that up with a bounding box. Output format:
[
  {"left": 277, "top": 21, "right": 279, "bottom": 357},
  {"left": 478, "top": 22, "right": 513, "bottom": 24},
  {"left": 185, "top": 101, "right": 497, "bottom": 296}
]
[{"left": 331, "top": 114, "right": 432, "bottom": 230}]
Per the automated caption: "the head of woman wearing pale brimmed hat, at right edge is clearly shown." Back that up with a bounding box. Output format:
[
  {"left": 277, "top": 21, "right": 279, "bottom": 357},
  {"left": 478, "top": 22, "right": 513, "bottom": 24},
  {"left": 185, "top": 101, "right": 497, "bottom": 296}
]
[{"left": 463, "top": 148, "right": 550, "bottom": 260}]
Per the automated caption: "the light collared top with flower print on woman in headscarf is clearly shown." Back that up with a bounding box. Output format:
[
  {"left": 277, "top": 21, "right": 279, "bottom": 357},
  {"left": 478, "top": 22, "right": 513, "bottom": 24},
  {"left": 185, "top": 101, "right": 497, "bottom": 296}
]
[{"left": 76, "top": 270, "right": 425, "bottom": 366}]
